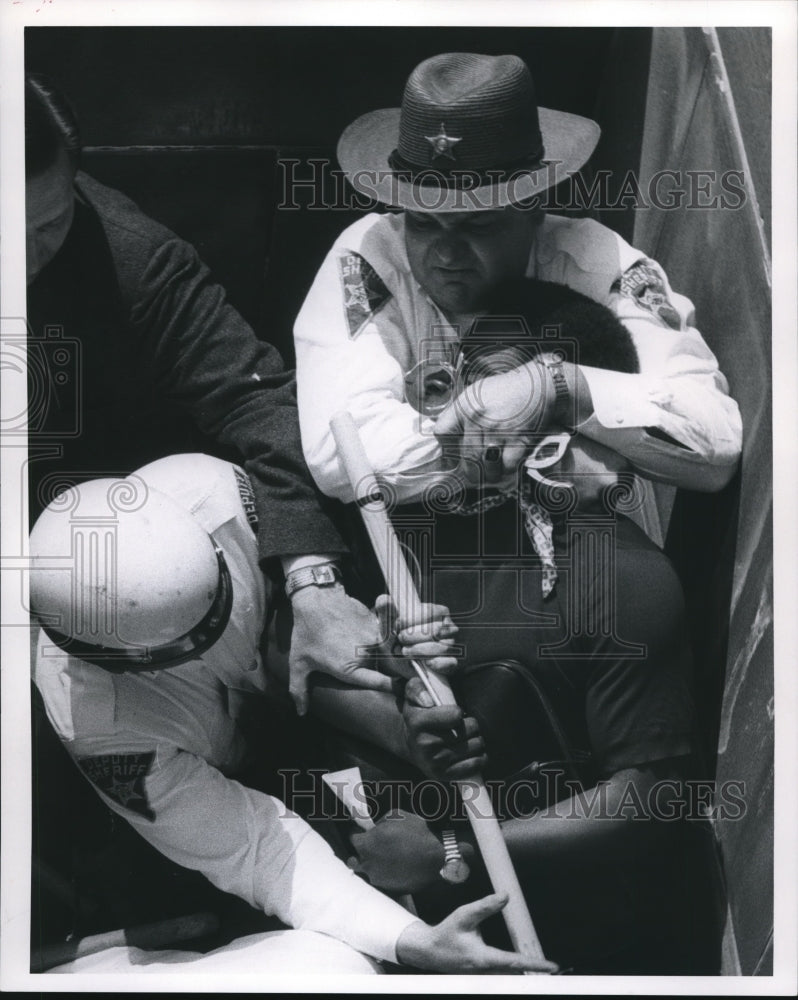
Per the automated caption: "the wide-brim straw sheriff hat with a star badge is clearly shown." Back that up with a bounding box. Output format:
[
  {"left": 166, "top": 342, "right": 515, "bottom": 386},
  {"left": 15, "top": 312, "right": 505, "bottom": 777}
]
[{"left": 338, "top": 52, "right": 601, "bottom": 212}]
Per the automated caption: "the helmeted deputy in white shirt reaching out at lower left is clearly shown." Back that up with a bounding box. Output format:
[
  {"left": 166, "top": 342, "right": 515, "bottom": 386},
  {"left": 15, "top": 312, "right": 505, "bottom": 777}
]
[{"left": 30, "top": 455, "right": 548, "bottom": 972}]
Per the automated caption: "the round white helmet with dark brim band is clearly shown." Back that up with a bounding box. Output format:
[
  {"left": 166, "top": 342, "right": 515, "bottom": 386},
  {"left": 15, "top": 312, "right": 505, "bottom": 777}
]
[{"left": 30, "top": 475, "right": 233, "bottom": 670}]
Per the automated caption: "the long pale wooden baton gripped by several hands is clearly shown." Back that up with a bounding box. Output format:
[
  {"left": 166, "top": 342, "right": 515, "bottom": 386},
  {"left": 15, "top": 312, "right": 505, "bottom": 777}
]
[{"left": 330, "top": 411, "right": 544, "bottom": 960}]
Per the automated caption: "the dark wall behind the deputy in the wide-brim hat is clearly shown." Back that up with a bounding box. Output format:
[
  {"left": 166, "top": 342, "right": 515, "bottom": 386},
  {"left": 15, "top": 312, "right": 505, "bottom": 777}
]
[{"left": 25, "top": 27, "right": 650, "bottom": 363}]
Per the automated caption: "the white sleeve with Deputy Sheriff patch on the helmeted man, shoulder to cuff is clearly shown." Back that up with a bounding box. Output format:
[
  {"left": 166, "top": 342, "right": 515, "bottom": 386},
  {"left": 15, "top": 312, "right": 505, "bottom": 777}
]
[{"left": 34, "top": 635, "right": 418, "bottom": 962}]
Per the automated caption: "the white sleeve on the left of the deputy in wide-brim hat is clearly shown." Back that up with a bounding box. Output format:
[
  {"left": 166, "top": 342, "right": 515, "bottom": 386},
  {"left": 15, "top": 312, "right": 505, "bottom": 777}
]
[{"left": 294, "top": 222, "right": 450, "bottom": 502}]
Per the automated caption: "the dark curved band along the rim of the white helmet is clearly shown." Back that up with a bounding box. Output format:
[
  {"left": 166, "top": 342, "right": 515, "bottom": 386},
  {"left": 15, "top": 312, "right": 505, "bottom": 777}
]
[{"left": 42, "top": 546, "right": 233, "bottom": 674}]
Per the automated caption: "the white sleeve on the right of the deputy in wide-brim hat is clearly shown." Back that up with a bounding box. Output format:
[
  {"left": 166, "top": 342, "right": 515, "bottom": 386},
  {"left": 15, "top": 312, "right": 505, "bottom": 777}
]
[{"left": 539, "top": 219, "right": 742, "bottom": 491}]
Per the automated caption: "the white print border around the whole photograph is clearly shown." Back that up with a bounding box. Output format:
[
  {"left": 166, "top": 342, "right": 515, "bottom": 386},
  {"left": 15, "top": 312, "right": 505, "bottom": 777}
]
[{"left": 0, "top": 0, "right": 798, "bottom": 995}]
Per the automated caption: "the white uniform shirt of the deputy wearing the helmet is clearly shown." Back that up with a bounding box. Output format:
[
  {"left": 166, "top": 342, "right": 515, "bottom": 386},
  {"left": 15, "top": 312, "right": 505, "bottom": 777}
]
[{"left": 34, "top": 456, "right": 417, "bottom": 961}]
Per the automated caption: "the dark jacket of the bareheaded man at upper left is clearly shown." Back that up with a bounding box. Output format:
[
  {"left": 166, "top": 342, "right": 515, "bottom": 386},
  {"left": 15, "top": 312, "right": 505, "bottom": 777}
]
[{"left": 28, "top": 173, "right": 344, "bottom": 561}]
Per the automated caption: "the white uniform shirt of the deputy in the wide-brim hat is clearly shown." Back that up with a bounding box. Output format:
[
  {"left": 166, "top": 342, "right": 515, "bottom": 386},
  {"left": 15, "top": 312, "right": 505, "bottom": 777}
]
[{"left": 294, "top": 214, "right": 742, "bottom": 502}]
